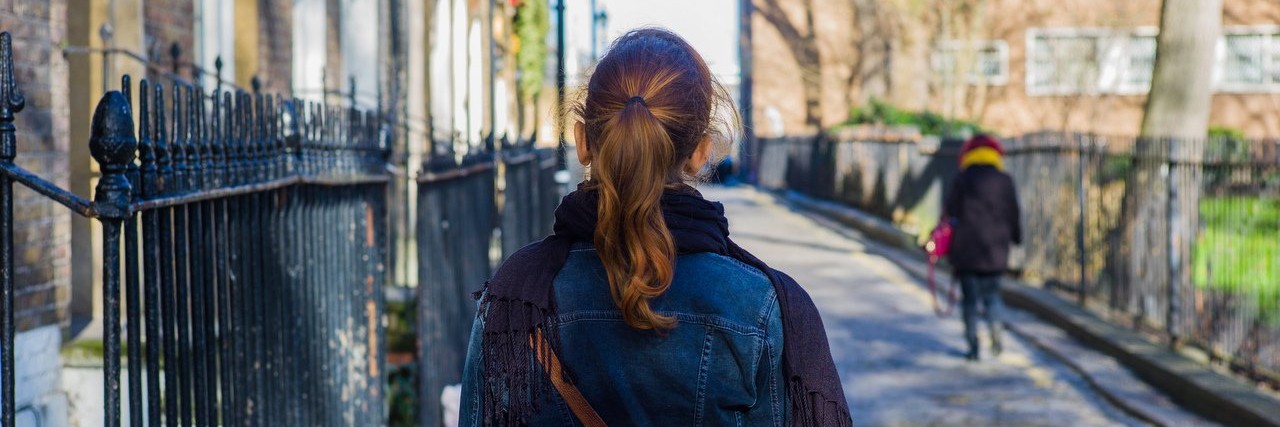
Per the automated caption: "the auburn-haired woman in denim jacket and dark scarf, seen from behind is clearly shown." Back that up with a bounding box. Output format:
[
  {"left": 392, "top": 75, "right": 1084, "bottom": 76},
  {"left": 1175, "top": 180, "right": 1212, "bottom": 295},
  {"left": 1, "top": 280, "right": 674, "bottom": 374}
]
[{"left": 461, "top": 29, "right": 851, "bottom": 426}]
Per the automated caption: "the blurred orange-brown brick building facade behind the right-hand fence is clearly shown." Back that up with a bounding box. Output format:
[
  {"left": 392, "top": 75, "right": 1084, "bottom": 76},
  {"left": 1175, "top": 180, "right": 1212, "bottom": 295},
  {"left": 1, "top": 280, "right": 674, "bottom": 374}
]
[{"left": 751, "top": 0, "right": 1280, "bottom": 138}]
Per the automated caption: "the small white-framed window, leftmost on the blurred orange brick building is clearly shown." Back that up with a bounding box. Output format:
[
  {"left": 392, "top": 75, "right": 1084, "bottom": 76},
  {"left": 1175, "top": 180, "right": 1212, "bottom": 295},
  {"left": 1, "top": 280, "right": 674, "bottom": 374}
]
[{"left": 932, "top": 40, "right": 1009, "bottom": 86}]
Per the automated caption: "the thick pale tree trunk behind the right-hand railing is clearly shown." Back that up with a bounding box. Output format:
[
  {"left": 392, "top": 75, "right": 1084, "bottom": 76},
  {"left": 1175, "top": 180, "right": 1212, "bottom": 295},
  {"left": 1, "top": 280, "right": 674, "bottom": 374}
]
[{"left": 1112, "top": 0, "right": 1222, "bottom": 340}]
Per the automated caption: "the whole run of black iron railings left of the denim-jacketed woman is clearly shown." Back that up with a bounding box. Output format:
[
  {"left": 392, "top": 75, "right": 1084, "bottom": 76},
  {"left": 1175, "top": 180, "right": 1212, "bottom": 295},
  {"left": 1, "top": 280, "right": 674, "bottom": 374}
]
[{"left": 0, "top": 26, "right": 562, "bottom": 427}]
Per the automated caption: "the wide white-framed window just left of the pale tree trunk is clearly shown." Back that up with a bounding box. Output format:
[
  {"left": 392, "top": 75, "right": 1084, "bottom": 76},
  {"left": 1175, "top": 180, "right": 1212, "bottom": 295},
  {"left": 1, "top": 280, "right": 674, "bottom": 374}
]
[{"left": 1027, "top": 28, "right": 1156, "bottom": 95}]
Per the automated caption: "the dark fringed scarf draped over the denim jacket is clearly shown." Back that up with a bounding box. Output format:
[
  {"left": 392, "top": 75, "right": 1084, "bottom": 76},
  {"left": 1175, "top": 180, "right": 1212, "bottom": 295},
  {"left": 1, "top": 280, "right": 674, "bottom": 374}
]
[{"left": 477, "top": 187, "right": 852, "bottom": 426}]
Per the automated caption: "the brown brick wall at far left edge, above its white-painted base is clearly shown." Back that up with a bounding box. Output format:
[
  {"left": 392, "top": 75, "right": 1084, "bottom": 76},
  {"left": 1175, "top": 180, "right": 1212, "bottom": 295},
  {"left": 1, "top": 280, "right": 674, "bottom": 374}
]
[{"left": 0, "top": 0, "right": 72, "bottom": 332}]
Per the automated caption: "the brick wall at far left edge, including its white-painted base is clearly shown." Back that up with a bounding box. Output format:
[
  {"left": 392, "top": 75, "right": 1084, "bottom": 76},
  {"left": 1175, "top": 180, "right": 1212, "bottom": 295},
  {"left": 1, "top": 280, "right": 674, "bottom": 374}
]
[{"left": 0, "top": 0, "right": 72, "bottom": 426}]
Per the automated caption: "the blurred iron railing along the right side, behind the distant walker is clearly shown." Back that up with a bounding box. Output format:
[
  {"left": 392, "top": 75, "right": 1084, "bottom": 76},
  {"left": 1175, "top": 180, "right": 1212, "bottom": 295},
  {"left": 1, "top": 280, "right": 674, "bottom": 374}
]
[{"left": 753, "top": 133, "right": 1280, "bottom": 384}]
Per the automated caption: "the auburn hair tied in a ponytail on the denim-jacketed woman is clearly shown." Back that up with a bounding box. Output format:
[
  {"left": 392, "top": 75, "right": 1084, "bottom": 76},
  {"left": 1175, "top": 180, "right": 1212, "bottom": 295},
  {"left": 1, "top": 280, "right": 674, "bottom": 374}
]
[{"left": 575, "top": 28, "right": 736, "bottom": 330}]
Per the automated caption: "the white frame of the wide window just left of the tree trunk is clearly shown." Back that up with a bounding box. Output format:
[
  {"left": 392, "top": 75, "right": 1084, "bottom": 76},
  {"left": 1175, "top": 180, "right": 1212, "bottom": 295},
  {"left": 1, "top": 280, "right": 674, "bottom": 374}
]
[{"left": 1024, "top": 27, "right": 1160, "bottom": 96}]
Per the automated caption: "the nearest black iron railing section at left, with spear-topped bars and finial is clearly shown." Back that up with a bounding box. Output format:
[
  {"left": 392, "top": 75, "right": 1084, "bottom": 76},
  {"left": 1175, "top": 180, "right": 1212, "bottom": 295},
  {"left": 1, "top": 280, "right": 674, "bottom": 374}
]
[{"left": 0, "top": 33, "right": 389, "bottom": 426}]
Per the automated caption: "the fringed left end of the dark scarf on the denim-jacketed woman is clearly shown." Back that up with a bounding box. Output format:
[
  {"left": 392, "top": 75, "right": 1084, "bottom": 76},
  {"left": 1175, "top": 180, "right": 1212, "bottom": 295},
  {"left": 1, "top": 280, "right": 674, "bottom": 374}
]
[{"left": 477, "top": 290, "right": 563, "bottom": 426}]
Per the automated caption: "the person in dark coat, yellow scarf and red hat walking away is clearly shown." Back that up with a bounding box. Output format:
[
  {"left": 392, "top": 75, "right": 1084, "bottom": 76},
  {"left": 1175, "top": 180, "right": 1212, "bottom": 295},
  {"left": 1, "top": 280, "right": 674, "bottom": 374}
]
[{"left": 946, "top": 136, "right": 1023, "bottom": 361}]
